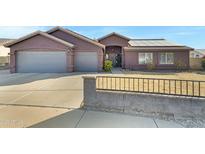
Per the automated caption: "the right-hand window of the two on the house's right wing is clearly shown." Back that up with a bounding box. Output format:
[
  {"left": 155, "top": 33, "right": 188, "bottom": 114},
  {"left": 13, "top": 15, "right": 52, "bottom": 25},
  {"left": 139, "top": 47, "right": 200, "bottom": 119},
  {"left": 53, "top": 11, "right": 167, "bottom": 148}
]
[{"left": 160, "top": 52, "right": 174, "bottom": 64}]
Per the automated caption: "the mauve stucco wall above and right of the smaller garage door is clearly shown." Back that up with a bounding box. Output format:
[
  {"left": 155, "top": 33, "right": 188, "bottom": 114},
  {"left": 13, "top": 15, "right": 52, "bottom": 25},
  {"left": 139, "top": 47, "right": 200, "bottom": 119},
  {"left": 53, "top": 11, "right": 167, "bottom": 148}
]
[{"left": 50, "top": 30, "right": 103, "bottom": 71}]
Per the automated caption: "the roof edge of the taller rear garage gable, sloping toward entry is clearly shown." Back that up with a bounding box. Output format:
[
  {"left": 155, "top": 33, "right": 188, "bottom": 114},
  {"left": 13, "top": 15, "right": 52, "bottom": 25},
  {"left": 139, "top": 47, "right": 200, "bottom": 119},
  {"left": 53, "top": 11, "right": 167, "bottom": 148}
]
[{"left": 47, "top": 26, "right": 105, "bottom": 48}]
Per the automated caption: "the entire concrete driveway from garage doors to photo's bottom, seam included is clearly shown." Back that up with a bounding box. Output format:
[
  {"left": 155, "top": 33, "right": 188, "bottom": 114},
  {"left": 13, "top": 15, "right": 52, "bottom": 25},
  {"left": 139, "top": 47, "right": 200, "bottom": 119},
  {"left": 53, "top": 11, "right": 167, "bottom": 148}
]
[{"left": 0, "top": 71, "right": 85, "bottom": 127}]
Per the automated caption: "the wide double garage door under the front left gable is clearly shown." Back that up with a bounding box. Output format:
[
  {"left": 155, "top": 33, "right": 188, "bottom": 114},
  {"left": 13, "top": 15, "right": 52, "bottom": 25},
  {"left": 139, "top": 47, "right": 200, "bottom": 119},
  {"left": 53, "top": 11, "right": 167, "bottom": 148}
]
[{"left": 16, "top": 51, "right": 67, "bottom": 73}]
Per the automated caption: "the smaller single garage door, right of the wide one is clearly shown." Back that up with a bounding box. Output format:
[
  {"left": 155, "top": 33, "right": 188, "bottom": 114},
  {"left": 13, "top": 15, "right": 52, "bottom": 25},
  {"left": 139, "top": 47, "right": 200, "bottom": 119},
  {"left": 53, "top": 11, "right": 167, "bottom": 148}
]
[{"left": 74, "top": 52, "right": 98, "bottom": 72}]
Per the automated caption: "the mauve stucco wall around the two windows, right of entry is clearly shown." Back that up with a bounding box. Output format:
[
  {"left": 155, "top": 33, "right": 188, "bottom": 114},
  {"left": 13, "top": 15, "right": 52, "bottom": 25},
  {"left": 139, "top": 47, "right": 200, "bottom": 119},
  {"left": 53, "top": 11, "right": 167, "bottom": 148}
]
[{"left": 124, "top": 50, "right": 189, "bottom": 69}]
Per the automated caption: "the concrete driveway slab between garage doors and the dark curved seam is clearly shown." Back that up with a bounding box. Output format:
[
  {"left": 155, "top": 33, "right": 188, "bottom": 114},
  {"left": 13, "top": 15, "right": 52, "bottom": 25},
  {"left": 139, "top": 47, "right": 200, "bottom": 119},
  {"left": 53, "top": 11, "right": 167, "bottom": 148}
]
[{"left": 0, "top": 73, "right": 83, "bottom": 108}]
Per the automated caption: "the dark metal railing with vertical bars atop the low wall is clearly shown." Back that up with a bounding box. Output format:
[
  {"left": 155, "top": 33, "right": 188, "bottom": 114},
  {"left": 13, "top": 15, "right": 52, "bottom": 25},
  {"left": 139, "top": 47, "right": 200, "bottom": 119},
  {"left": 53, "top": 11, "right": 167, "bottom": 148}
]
[{"left": 96, "top": 76, "right": 205, "bottom": 97}]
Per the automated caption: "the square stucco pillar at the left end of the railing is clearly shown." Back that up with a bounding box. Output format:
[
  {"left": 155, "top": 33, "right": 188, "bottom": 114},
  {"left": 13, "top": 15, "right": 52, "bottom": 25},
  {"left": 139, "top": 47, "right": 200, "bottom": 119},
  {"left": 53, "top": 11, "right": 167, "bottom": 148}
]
[{"left": 83, "top": 76, "right": 96, "bottom": 106}]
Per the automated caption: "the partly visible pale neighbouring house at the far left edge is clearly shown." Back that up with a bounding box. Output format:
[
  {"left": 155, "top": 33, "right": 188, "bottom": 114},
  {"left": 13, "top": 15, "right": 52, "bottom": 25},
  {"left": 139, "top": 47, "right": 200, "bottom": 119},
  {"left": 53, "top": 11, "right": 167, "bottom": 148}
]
[{"left": 0, "top": 38, "right": 12, "bottom": 65}]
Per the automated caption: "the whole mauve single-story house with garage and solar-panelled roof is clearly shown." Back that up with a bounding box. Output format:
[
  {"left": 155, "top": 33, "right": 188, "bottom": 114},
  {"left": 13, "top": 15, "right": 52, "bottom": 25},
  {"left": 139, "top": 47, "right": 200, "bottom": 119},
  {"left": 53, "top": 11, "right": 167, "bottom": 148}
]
[{"left": 5, "top": 27, "right": 193, "bottom": 73}]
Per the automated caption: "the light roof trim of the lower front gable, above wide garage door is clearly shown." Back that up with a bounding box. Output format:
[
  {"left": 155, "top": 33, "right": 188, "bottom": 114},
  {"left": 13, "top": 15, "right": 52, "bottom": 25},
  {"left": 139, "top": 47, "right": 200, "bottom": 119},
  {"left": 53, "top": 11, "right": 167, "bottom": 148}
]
[{"left": 4, "top": 31, "right": 74, "bottom": 48}]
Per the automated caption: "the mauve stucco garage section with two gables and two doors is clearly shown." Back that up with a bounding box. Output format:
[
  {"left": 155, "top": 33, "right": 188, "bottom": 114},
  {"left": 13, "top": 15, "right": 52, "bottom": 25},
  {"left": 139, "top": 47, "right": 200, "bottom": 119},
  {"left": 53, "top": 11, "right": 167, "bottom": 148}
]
[{"left": 4, "top": 27, "right": 105, "bottom": 73}]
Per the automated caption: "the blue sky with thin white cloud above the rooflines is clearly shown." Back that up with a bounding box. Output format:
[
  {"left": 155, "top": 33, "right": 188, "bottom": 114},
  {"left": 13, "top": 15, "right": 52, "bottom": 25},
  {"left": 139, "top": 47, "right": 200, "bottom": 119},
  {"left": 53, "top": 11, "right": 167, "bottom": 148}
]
[{"left": 0, "top": 26, "right": 205, "bottom": 49}]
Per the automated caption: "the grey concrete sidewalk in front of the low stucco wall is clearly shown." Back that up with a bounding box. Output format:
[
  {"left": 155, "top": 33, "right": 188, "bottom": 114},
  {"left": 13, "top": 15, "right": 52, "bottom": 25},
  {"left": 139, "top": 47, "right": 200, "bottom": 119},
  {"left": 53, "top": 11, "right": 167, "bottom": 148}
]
[{"left": 32, "top": 109, "right": 182, "bottom": 128}]
